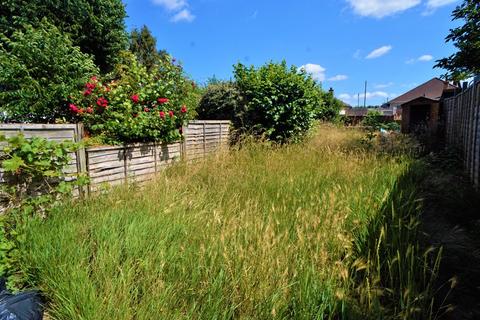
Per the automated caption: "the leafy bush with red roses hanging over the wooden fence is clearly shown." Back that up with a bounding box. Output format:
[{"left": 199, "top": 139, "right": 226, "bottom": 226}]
[{"left": 69, "top": 52, "right": 193, "bottom": 144}]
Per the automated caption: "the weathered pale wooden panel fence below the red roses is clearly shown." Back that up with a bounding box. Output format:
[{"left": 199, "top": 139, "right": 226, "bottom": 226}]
[{"left": 0, "top": 120, "right": 230, "bottom": 193}]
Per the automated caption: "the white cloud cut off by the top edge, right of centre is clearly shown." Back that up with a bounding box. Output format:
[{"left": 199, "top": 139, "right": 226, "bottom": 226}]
[{"left": 347, "top": 0, "right": 420, "bottom": 18}]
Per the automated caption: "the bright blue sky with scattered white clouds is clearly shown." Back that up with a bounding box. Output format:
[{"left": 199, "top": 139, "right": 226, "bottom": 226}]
[{"left": 124, "top": 0, "right": 460, "bottom": 105}]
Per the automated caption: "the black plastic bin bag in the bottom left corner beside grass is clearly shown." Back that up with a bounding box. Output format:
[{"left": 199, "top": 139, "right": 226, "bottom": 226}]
[{"left": 0, "top": 279, "right": 43, "bottom": 320}]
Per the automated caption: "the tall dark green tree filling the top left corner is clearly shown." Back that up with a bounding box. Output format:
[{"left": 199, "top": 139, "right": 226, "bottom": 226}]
[{"left": 0, "top": 0, "right": 128, "bottom": 71}]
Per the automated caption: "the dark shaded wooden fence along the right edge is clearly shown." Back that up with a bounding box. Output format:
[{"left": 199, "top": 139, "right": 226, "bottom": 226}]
[{"left": 444, "top": 82, "right": 480, "bottom": 188}]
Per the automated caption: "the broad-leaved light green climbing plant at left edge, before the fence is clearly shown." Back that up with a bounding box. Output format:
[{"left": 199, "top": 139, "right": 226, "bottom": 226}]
[{"left": 0, "top": 135, "right": 88, "bottom": 284}]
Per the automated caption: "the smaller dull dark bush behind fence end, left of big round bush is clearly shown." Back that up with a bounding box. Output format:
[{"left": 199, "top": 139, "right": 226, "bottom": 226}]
[{"left": 197, "top": 82, "right": 242, "bottom": 126}]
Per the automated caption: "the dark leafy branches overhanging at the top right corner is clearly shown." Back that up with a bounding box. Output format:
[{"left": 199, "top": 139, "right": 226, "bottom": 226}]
[{"left": 435, "top": 0, "right": 480, "bottom": 80}]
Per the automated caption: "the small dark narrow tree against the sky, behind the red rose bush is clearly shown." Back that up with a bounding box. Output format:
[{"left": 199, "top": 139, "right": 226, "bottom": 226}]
[{"left": 130, "top": 25, "right": 160, "bottom": 72}]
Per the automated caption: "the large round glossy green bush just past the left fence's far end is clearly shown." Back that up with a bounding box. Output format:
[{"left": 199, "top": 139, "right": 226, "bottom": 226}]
[{"left": 234, "top": 61, "right": 323, "bottom": 143}]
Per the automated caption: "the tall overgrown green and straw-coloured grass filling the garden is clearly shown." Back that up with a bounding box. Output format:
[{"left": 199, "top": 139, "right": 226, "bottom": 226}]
[{"left": 16, "top": 127, "right": 438, "bottom": 319}]
